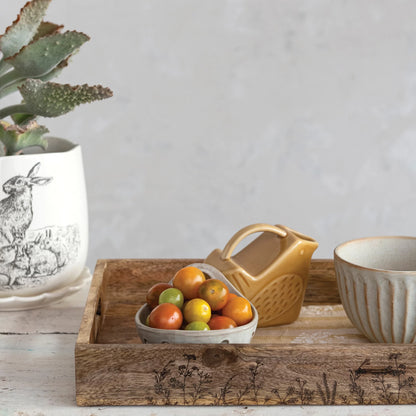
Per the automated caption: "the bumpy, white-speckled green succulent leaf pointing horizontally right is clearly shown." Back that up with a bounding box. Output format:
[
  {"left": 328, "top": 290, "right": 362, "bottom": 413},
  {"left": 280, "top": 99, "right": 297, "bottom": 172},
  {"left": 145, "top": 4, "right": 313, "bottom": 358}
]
[{"left": 19, "top": 79, "right": 113, "bottom": 117}]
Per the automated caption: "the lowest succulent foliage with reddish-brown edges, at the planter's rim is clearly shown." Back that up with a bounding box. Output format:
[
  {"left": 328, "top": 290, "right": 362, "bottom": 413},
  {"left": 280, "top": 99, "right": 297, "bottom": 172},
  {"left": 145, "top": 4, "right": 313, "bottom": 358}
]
[{"left": 0, "top": 121, "right": 49, "bottom": 155}]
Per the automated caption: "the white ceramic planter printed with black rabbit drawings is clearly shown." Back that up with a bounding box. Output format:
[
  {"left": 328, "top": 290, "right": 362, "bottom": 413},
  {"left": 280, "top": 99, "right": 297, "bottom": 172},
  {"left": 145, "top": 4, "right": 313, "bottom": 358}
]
[{"left": 0, "top": 138, "right": 88, "bottom": 304}]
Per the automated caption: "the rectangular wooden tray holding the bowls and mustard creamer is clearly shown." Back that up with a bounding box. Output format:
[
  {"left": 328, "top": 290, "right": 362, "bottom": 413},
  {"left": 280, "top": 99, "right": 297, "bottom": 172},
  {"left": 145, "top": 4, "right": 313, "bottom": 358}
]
[{"left": 75, "top": 259, "right": 416, "bottom": 406}]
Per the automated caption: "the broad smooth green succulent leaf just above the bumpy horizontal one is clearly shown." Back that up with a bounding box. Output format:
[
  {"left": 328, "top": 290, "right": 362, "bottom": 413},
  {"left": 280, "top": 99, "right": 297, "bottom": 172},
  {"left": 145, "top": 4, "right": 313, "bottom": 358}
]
[{"left": 6, "top": 31, "right": 89, "bottom": 78}]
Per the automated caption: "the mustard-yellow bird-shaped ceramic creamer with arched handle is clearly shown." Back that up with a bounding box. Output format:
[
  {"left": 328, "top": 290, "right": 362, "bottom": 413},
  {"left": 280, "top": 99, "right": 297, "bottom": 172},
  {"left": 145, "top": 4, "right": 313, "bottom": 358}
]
[{"left": 205, "top": 224, "right": 318, "bottom": 327}]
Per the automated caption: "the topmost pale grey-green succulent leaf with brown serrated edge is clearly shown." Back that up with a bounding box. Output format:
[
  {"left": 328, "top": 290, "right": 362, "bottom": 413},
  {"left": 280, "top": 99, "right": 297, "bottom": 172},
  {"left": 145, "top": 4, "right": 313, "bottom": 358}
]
[{"left": 0, "top": 0, "right": 51, "bottom": 58}]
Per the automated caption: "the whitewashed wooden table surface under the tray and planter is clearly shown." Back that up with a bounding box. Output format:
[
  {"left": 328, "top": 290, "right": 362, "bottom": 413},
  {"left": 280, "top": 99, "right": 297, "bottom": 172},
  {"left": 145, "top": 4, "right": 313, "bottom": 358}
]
[{"left": 0, "top": 276, "right": 416, "bottom": 416}]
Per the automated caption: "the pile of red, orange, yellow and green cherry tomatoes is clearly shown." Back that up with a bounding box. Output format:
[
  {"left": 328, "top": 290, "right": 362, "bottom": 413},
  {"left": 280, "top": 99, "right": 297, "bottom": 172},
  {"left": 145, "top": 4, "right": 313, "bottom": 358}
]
[{"left": 146, "top": 266, "right": 253, "bottom": 331}]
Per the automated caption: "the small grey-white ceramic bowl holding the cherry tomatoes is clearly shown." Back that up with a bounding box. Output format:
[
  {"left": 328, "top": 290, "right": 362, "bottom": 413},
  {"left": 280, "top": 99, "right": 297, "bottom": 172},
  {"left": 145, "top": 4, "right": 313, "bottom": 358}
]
[{"left": 136, "top": 263, "right": 259, "bottom": 344}]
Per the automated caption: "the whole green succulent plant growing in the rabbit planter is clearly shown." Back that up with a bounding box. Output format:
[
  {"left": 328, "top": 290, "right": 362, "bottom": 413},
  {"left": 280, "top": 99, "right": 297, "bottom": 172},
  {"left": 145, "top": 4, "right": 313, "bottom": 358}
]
[{"left": 0, "top": 0, "right": 113, "bottom": 156}]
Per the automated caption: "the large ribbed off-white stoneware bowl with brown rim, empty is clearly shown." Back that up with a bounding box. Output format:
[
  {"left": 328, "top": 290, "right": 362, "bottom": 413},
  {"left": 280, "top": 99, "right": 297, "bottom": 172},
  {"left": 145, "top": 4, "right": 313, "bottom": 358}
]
[{"left": 334, "top": 237, "right": 416, "bottom": 344}]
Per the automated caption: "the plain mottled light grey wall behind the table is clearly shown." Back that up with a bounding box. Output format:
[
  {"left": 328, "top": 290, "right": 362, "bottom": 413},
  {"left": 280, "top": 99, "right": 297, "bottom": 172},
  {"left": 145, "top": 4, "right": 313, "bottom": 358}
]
[{"left": 0, "top": 0, "right": 416, "bottom": 268}]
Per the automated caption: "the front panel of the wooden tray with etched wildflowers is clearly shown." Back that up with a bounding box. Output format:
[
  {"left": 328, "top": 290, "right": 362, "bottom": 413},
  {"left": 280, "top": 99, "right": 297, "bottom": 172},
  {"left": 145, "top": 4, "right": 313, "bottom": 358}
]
[{"left": 76, "top": 344, "right": 416, "bottom": 406}]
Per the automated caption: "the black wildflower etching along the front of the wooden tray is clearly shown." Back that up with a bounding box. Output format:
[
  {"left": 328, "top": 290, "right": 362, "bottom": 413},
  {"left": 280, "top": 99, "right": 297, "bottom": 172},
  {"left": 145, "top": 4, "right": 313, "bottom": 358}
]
[{"left": 147, "top": 353, "right": 416, "bottom": 406}]
